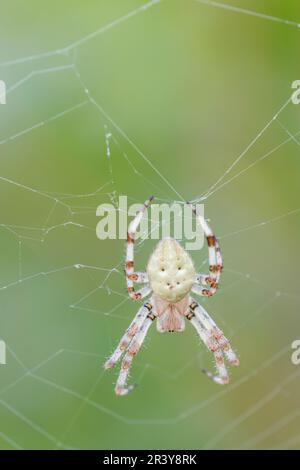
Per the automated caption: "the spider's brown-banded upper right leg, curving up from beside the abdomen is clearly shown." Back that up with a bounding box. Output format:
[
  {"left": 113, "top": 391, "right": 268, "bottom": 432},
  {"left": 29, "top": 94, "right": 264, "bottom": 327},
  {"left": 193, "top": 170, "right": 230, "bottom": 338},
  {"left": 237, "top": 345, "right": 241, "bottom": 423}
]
[{"left": 189, "top": 204, "right": 223, "bottom": 297}]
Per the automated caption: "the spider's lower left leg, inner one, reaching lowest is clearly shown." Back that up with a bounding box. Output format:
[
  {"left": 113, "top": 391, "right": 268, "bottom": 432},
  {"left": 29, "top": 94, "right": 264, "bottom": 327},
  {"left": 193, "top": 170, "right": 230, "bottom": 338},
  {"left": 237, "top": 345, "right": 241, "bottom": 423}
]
[{"left": 115, "top": 312, "right": 156, "bottom": 395}]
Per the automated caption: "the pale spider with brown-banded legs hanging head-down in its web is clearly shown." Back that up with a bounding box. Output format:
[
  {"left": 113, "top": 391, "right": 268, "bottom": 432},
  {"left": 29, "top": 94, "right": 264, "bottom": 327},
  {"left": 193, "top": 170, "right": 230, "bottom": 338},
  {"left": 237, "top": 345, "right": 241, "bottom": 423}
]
[{"left": 104, "top": 196, "right": 239, "bottom": 395}]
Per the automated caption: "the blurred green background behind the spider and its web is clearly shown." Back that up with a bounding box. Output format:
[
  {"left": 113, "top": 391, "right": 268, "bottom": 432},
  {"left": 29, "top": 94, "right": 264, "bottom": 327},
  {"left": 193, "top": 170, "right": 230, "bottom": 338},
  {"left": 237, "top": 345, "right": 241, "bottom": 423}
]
[{"left": 0, "top": 0, "right": 300, "bottom": 449}]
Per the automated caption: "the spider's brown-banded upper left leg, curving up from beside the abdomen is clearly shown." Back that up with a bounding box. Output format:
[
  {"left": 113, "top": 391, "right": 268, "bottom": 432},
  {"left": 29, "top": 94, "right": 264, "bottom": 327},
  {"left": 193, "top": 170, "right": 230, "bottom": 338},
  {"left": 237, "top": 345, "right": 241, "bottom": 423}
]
[{"left": 125, "top": 196, "right": 153, "bottom": 300}]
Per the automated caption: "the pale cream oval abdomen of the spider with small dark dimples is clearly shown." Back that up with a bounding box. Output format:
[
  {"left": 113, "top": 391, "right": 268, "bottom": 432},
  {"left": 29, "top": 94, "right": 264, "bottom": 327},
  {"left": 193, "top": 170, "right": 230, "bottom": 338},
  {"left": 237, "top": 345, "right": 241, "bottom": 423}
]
[{"left": 147, "top": 238, "right": 195, "bottom": 303}]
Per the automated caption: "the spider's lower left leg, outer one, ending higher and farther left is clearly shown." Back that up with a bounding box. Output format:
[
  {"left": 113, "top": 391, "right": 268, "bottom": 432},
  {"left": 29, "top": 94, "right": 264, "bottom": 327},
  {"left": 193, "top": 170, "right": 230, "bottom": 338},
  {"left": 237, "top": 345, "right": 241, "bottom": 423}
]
[{"left": 104, "top": 302, "right": 152, "bottom": 369}]
